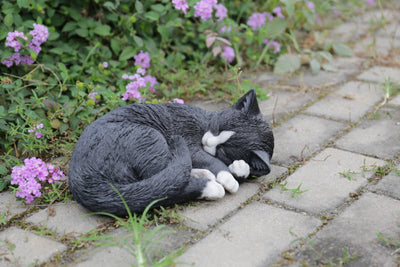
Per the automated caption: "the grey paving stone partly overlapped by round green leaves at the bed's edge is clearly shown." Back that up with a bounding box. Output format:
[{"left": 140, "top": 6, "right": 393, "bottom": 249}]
[{"left": 285, "top": 57, "right": 364, "bottom": 87}]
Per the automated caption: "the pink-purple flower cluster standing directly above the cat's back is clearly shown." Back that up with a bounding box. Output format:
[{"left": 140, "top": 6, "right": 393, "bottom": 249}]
[{"left": 122, "top": 51, "right": 158, "bottom": 102}]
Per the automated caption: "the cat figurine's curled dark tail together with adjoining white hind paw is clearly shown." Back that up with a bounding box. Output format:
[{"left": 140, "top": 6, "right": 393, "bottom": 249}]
[{"left": 70, "top": 136, "right": 220, "bottom": 216}]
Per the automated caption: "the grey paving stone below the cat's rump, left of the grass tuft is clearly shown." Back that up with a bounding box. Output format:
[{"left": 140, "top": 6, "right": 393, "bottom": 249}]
[{"left": 26, "top": 201, "right": 111, "bottom": 237}]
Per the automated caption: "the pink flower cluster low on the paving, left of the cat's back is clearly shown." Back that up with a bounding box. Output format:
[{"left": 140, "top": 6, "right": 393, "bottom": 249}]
[{"left": 11, "top": 158, "right": 65, "bottom": 203}]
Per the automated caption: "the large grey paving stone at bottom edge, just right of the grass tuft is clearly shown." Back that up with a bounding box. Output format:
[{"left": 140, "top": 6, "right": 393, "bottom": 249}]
[{"left": 177, "top": 202, "right": 321, "bottom": 267}]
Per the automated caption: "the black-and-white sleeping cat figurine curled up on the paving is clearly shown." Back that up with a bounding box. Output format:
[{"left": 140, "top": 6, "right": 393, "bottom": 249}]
[{"left": 69, "top": 90, "right": 274, "bottom": 216}]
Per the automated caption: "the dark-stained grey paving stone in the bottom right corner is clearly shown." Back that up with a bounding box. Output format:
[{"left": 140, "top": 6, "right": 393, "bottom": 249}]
[{"left": 299, "top": 193, "right": 400, "bottom": 266}]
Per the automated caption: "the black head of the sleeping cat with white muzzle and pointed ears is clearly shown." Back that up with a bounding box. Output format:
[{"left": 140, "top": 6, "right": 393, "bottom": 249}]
[{"left": 202, "top": 90, "right": 274, "bottom": 176}]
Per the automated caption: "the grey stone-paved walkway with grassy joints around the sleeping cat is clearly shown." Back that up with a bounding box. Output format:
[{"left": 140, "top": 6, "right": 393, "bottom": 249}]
[{"left": 0, "top": 7, "right": 400, "bottom": 267}]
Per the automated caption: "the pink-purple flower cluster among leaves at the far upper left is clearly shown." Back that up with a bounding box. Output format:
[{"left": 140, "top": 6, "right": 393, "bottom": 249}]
[{"left": 1, "top": 23, "right": 49, "bottom": 67}]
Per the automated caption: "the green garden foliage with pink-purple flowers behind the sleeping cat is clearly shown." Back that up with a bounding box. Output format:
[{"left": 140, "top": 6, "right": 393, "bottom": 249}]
[{"left": 0, "top": 0, "right": 366, "bottom": 201}]
